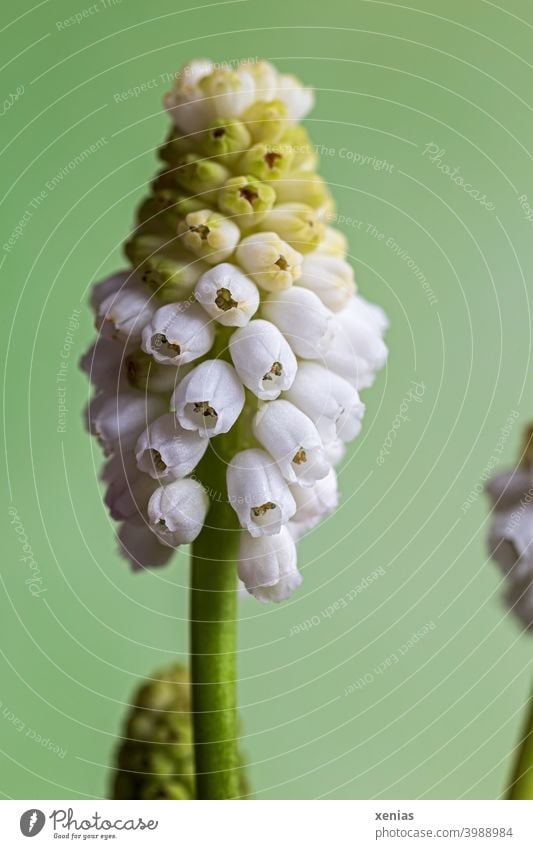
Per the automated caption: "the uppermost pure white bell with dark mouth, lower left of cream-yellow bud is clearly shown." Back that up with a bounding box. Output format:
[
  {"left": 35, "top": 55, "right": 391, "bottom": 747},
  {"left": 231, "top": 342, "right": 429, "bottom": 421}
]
[{"left": 194, "top": 262, "right": 259, "bottom": 327}]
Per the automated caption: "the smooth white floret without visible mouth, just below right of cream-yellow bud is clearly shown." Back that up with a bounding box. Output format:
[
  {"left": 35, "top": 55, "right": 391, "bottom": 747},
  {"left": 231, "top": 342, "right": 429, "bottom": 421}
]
[{"left": 262, "top": 286, "right": 334, "bottom": 360}]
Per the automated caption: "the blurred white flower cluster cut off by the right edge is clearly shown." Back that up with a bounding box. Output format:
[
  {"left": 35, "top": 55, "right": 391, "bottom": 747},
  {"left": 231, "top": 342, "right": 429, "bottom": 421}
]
[{"left": 486, "top": 454, "right": 533, "bottom": 629}]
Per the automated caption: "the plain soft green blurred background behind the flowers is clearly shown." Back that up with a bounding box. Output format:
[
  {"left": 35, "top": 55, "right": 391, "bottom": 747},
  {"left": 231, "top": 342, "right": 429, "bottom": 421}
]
[{"left": 0, "top": 0, "right": 533, "bottom": 799}]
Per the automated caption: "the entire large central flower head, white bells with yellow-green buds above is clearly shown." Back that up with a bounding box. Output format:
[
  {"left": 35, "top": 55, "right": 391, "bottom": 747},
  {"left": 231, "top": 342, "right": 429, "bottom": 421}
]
[{"left": 83, "top": 60, "right": 387, "bottom": 601}]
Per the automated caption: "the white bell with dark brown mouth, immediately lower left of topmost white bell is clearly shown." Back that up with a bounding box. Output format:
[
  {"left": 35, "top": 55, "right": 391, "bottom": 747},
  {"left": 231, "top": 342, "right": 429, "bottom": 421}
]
[{"left": 142, "top": 302, "right": 215, "bottom": 365}]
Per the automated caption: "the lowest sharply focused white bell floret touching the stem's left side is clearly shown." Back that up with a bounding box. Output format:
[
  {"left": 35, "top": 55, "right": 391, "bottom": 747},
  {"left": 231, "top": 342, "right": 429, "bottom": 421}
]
[{"left": 148, "top": 478, "right": 209, "bottom": 548}]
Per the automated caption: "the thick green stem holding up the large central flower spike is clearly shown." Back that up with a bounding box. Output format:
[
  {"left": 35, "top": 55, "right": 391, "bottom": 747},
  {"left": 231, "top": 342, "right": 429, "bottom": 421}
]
[{"left": 190, "top": 440, "right": 239, "bottom": 799}]
